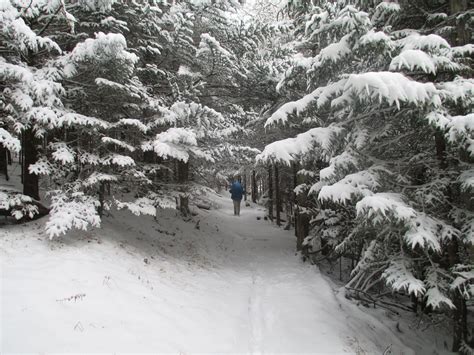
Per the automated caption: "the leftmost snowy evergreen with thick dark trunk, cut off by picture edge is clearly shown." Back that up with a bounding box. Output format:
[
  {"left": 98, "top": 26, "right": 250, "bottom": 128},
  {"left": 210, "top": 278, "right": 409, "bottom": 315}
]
[{"left": 0, "top": 1, "right": 68, "bottom": 219}]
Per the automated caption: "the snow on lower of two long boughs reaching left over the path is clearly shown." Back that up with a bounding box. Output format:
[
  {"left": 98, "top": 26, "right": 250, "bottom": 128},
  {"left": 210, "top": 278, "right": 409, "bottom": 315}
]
[{"left": 256, "top": 126, "right": 343, "bottom": 165}]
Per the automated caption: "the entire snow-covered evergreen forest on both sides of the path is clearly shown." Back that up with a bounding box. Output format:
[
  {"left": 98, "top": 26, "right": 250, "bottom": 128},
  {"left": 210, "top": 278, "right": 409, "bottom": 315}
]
[{"left": 0, "top": 0, "right": 474, "bottom": 354}]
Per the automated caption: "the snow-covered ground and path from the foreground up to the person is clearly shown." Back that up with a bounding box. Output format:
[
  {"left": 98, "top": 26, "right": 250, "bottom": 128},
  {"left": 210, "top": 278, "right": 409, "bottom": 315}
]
[{"left": 0, "top": 197, "right": 407, "bottom": 353}]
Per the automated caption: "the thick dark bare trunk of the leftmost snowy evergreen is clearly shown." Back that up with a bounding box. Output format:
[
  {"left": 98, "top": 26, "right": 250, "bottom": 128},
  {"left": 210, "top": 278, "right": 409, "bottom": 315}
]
[{"left": 22, "top": 128, "right": 40, "bottom": 200}]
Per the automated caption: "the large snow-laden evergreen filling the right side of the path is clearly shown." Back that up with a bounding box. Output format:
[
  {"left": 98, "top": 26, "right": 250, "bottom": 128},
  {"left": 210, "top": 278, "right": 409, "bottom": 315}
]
[{"left": 257, "top": 1, "right": 474, "bottom": 350}]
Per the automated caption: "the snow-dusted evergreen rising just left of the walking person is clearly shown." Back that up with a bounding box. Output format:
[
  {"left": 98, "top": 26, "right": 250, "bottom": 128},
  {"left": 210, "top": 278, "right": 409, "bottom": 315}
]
[{"left": 134, "top": 1, "right": 288, "bottom": 209}]
